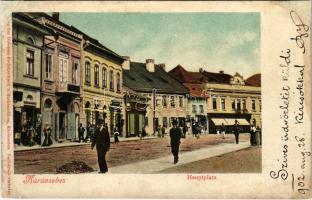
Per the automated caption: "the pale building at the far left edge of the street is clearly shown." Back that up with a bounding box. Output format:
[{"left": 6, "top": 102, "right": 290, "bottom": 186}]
[{"left": 13, "top": 13, "right": 51, "bottom": 144}]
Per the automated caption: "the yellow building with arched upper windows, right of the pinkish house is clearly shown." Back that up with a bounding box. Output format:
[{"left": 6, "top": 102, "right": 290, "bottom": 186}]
[{"left": 81, "top": 35, "right": 123, "bottom": 134}]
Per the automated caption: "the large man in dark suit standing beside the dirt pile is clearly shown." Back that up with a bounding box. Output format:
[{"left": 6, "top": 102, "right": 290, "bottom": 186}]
[{"left": 91, "top": 124, "right": 110, "bottom": 173}]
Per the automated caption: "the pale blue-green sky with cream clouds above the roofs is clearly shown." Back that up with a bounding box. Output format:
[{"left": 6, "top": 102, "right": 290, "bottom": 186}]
[{"left": 60, "top": 13, "right": 260, "bottom": 78}]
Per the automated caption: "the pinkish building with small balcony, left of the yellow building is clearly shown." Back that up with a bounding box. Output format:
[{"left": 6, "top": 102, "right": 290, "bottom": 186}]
[{"left": 29, "top": 13, "right": 83, "bottom": 142}]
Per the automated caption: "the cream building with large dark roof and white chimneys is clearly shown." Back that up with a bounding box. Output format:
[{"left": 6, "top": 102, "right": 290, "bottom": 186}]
[{"left": 123, "top": 58, "right": 188, "bottom": 135}]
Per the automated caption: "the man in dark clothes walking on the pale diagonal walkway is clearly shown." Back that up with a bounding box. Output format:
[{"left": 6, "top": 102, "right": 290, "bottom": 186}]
[{"left": 170, "top": 120, "right": 182, "bottom": 164}]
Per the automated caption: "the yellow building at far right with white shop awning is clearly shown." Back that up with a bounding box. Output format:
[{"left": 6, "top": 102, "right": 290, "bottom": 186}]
[{"left": 203, "top": 71, "right": 261, "bottom": 133}]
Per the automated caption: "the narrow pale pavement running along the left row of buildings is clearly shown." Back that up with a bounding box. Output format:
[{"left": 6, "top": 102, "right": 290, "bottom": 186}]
[{"left": 14, "top": 136, "right": 158, "bottom": 152}]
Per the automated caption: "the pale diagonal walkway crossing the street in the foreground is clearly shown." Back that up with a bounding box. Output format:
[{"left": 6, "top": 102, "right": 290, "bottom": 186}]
[{"left": 106, "top": 142, "right": 250, "bottom": 174}]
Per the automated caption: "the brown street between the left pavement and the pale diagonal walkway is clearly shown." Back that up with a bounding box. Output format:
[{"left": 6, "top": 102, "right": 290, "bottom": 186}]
[{"left": 14, "top": 134, "right": 249, "bottom": 174}]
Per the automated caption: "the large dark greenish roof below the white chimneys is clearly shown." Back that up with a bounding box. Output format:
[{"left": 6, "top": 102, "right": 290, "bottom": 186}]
[{"left": 123, "top": 62, "right": 188, "bottom": 94}]
